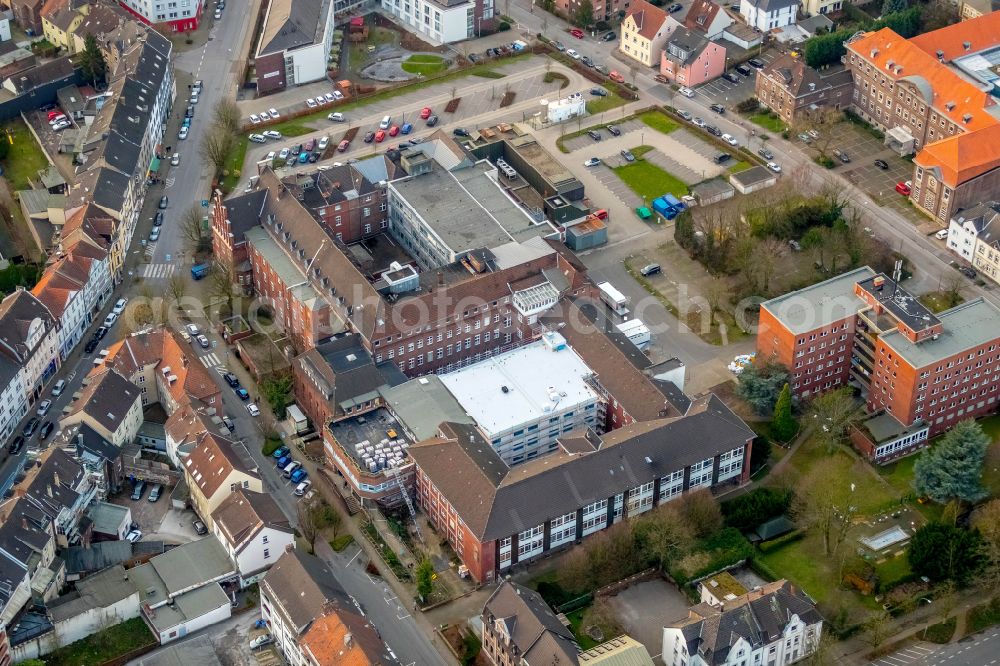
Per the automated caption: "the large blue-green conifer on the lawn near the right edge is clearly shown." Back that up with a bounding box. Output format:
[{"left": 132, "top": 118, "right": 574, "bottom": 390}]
[{"left": 913, "top": 419, "right": 990, "bottom": 504}]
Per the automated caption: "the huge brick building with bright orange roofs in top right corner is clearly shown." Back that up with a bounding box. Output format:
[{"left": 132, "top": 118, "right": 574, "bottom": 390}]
[{"left": 845, "top": 12, "right": 1000, "bottom": 225}]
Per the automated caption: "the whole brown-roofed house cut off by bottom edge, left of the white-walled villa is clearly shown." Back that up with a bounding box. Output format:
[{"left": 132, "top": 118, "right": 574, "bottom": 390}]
[{"left": 482, "top": 580, "right": 579, "bottom": 666}]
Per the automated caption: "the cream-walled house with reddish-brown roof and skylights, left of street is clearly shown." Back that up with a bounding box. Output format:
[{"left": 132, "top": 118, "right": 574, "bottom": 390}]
[{"left": 184, "top": 432, "right": 264, "bottom": 532}]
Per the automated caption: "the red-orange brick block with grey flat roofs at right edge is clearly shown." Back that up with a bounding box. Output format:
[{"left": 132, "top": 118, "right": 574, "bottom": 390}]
[{"left": 757, "top": 267, "right": 1000, "bottom": 463}]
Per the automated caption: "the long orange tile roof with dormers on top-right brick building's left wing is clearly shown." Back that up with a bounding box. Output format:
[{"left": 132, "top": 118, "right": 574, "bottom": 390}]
[{"left": 847, "top": 24, "right": 998, "bottom": 132}]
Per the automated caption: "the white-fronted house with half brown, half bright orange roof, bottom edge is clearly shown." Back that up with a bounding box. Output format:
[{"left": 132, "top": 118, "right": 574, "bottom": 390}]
[{"left": 260, "top": 549, "right": 395, "bottom": 666}]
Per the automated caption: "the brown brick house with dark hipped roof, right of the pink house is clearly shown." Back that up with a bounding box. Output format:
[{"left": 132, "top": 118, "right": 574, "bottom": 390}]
[{"left": 754, "top": 54, "right": 854, "bottom": 125}]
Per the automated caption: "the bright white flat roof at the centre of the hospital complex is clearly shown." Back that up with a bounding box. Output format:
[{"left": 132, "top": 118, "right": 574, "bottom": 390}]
[{"left": 439, "top": 341, "right": 598, "bottom": 437}]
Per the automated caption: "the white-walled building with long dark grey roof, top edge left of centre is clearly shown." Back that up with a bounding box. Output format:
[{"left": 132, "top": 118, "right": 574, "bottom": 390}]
[{"left": 254, "top": 0, "right": 334, "bottom": 94}]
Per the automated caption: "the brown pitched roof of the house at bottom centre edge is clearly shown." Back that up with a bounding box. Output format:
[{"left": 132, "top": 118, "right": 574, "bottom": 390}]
[{"left": 483, "top": 580, "right": 578, "bottom": 666}]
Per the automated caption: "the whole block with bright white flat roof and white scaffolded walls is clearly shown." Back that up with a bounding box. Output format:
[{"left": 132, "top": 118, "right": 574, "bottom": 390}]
[{"left": 439, "top": 331, "right": 604, "bottom": 466}]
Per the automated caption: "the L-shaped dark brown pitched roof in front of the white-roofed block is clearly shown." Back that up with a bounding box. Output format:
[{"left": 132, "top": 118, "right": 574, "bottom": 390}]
[{"left": 409, "top": 395, "right": 754, "bottom": 541}]
